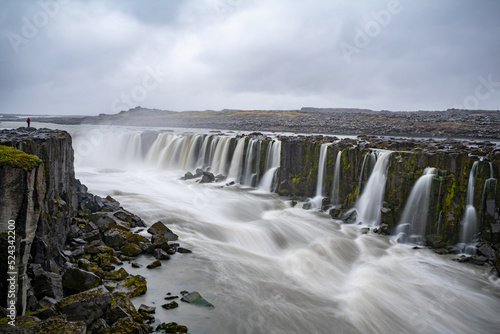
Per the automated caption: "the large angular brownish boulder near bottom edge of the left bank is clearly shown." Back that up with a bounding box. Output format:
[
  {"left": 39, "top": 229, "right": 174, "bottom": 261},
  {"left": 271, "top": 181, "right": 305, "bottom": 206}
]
[{"left": 59, "top": 286, "right": 112, "bottom": 326}]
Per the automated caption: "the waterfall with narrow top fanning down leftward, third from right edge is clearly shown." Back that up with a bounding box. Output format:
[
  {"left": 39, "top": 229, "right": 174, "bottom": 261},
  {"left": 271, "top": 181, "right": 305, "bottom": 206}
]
[{"left": 396, "top": 168, "right": 437, "bottom": 245}]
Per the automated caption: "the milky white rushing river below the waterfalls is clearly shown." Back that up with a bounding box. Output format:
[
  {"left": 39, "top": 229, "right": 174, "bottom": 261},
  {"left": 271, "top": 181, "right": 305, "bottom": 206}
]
[{"left": 3, "top": 122, "right": 500, "bottom": 334}]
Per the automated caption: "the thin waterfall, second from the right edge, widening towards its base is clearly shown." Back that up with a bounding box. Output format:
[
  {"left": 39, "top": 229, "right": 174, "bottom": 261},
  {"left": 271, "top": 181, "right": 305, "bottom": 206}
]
[{"left": 459, "top": 161, "right": 478, "bottom": 253}]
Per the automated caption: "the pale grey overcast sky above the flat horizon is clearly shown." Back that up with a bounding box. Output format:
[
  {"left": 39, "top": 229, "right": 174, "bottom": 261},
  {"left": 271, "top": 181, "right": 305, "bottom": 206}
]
[{"left": 0, "top": 0, "right": 500, "bottom": 115}]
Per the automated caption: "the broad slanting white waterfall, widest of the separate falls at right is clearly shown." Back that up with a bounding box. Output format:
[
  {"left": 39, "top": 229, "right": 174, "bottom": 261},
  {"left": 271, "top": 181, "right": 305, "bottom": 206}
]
[{"left": 354, "top": 151, "right": 392, "bottom": 226}]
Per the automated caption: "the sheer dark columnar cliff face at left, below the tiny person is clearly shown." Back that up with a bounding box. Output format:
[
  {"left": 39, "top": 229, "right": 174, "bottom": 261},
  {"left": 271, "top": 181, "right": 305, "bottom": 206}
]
[{"left": 0, "top": 128, "right": 77, "bottom": 314}]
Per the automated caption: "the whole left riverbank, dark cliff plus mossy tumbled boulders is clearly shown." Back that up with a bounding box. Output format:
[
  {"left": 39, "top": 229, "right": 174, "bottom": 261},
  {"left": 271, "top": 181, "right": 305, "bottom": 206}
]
[{"left": 0, "top": 128, "right": 192, "bottom": 333}]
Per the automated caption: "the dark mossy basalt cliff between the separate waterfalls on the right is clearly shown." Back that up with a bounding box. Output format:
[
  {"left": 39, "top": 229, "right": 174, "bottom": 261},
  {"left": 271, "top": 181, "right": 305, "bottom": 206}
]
[{"left": 278, "top": 136, "right": 500, "bottom": 244}]
